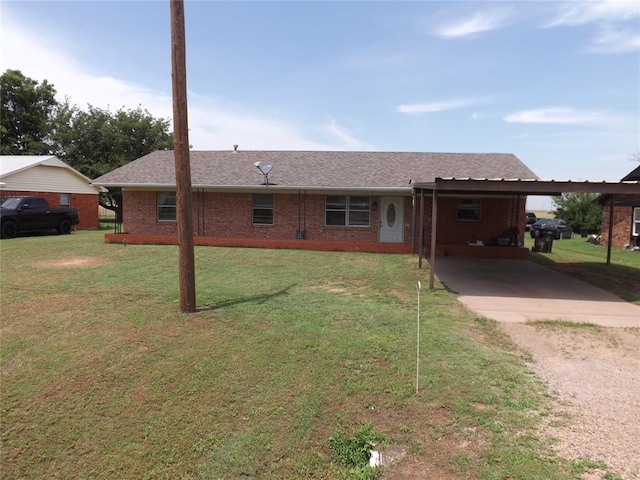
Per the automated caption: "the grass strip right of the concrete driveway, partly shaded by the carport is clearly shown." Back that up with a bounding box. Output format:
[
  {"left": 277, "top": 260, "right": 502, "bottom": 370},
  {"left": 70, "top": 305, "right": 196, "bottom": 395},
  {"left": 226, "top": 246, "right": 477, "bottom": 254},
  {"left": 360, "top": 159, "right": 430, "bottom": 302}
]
[{"left": 525, "top": 234, "right": 640, "bottom": 305}]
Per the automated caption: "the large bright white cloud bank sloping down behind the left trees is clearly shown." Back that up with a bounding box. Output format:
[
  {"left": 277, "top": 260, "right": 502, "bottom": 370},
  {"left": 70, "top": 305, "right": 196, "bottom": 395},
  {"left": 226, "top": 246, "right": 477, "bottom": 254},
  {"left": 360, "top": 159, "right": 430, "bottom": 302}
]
[{"left": 0, "top": 15, "right": 359, "bottom": 150}]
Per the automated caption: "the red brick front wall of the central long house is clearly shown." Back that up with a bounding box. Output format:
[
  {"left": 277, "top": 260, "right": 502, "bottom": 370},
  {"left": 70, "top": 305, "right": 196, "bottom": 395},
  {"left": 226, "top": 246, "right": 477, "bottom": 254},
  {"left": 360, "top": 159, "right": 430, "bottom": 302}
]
[{"left": 119, "top": 191, "right": 525, "bottom": 256}]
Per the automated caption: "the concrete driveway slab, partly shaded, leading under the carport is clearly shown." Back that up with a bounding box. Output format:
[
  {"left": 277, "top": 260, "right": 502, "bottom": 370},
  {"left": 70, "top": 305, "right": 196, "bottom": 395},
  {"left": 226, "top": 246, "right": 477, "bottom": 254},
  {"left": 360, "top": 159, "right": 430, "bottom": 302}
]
[{"left": 435, "top": 257, "right": 640, "bottom": 327}]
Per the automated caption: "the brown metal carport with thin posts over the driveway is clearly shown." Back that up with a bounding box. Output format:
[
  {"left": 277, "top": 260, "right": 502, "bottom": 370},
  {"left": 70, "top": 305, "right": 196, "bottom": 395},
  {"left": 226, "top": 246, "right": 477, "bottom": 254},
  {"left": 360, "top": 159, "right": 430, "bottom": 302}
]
[{"left": 414, "top": 178, "right": 640, "bottom": 288}]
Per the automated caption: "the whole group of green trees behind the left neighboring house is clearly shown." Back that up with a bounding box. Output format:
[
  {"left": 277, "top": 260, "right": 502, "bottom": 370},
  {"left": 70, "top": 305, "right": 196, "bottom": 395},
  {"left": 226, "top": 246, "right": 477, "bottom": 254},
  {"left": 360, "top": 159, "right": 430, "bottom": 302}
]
[{"left": 0, "top": 70, "right": 173, "bottom": 219}]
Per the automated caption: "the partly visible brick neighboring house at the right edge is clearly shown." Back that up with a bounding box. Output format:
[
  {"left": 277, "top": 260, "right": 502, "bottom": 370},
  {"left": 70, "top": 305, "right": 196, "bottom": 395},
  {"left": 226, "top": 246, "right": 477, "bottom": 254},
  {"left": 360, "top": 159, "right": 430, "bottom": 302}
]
[{"left": 598, "top": 166, "right": 640, "bottom": 248}]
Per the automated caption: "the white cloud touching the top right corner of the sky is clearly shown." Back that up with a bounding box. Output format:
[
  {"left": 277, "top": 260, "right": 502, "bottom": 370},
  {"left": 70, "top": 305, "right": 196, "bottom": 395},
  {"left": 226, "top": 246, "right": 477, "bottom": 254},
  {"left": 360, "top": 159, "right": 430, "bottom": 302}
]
[{"left": 544, "top": 0, "right": 640, "bottom": 27}]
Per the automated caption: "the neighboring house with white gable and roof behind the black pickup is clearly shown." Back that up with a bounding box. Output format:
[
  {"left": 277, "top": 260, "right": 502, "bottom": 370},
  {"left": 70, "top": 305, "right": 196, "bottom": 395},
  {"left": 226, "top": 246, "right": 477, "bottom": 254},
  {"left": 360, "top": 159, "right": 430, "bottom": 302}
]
[{"left": 0, "top": 155, "right": 102, "bottom": 229}]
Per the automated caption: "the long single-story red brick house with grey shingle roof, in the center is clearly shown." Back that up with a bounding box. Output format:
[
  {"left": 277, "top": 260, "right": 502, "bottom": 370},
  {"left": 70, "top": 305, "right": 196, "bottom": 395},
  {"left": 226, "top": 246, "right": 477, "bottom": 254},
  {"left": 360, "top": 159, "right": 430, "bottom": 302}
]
[{"left": 93, "top": 149, "right": 538, "bottom": 257}]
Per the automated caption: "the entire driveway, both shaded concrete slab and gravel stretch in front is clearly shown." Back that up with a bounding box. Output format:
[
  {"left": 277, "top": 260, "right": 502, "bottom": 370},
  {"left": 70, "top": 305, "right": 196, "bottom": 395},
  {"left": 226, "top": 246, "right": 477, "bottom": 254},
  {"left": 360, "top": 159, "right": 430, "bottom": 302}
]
[{"left": 435, "top": 257, "right": 640, "bottom": 480}]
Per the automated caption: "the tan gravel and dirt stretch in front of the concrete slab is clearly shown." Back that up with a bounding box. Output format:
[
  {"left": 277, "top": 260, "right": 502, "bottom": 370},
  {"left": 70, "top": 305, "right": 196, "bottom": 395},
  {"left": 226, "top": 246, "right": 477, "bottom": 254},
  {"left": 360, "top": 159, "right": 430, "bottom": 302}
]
[{"left": 502, "top": 323, "right": 640, "bottom": 480}]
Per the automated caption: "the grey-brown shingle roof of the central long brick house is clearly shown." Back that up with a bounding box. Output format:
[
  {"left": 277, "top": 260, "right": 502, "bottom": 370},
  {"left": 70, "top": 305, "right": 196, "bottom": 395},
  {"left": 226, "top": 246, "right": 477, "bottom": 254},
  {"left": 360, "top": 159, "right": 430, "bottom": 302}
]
[{"left": 93, "top": 150, "right": 538, "bottom": 189}]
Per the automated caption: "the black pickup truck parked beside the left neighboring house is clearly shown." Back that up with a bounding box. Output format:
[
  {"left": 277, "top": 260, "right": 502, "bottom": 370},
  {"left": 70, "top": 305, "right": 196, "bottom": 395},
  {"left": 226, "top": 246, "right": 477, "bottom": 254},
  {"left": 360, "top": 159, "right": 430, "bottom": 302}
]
[{"left": 0, "top": 197, "right": 79, "bottom": 238}]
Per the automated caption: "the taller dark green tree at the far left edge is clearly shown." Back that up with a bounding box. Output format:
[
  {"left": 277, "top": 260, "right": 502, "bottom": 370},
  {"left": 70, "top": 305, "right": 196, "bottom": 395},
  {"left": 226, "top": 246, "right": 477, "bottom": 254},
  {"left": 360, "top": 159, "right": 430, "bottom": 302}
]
[{"left": 0, "top": 70, "right": 57, "bottom": 155}]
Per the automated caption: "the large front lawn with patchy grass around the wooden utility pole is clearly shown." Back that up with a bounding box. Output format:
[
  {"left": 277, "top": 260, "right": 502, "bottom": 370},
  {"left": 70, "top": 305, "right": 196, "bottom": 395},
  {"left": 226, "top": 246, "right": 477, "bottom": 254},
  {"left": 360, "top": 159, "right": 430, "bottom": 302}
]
[{"left": 0, "top": 231, "right": 632, "bottom": 480}]
